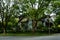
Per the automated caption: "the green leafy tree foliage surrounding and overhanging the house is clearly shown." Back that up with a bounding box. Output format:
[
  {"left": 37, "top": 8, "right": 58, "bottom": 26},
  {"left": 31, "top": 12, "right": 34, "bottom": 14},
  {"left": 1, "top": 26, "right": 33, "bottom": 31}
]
[{"left": 0, "top": 0, "right": 60, "bottom": 31}]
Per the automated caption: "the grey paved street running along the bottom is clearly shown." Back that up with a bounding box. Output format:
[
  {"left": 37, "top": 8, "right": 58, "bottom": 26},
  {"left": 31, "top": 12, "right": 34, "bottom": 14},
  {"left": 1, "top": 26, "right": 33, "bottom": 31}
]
[{"left": 0, "top": 35, "right": 60, "bottom": 40}]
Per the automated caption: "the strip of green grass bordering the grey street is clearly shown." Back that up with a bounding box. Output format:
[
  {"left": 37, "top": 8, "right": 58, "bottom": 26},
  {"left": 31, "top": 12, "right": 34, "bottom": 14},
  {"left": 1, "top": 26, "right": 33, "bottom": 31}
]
[{"left": 0, "top": 33, "right": 52, "bottom": 36}]
